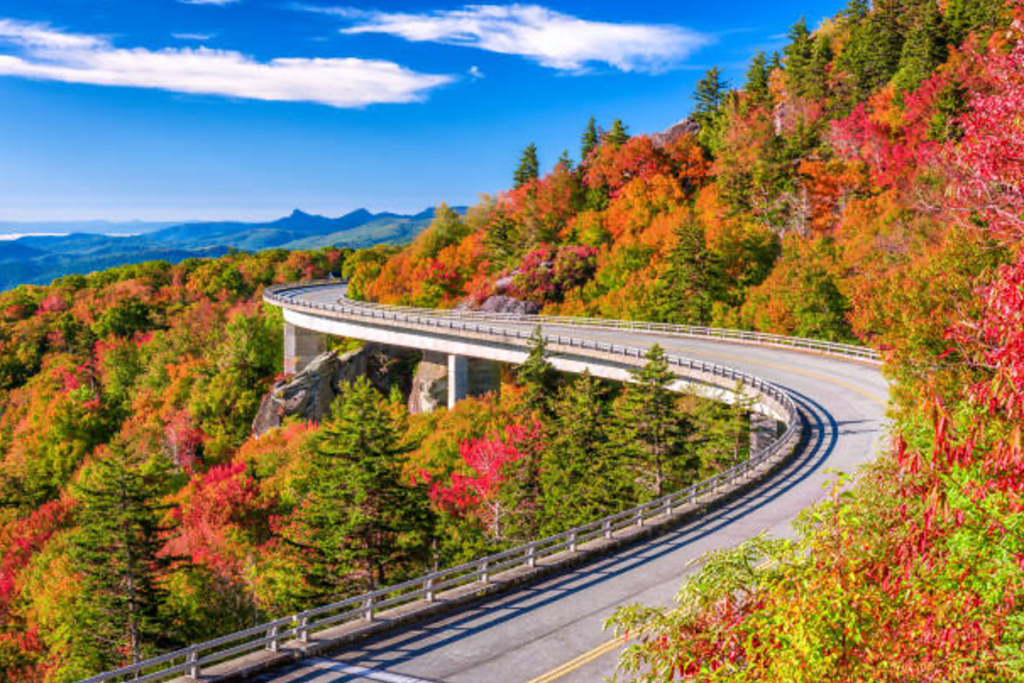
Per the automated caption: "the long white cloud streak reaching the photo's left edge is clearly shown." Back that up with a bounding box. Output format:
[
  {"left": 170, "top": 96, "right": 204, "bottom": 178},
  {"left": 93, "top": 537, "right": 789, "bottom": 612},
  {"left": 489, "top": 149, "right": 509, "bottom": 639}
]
[{"left": 0, "top": 19, "right": 455, "bottom": 108}]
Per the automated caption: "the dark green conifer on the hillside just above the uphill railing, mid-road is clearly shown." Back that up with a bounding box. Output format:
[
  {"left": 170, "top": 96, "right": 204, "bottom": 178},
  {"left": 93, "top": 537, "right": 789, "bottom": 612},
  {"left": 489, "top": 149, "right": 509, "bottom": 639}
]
[{"left": 658, "top": 216, "right": 717, "bottom": 325}]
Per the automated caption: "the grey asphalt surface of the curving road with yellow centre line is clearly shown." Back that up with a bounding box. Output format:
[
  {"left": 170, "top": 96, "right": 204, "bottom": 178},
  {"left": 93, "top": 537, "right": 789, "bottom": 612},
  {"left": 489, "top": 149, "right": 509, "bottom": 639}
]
[{"left": 258, "top": 288, "right": 889, "bottom": 683}]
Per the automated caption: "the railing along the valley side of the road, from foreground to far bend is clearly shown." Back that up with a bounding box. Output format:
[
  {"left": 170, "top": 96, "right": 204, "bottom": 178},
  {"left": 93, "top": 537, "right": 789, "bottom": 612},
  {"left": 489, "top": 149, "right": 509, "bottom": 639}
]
[{"left": 79, "top": 283, "right": 815, "bottom": 683}]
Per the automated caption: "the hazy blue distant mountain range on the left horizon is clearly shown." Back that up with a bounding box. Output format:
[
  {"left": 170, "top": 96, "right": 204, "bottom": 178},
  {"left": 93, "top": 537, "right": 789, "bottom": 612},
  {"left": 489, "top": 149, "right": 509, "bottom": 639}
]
[{"left": 0, "top": 208, "right": 456, "bottom": 290}]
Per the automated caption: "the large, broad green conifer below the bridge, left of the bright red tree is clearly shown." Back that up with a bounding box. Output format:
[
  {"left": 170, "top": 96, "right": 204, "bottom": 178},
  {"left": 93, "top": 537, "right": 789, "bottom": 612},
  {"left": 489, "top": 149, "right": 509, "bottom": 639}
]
[{"left": 289, "top": 377, "right": 431, "bottom": 600}]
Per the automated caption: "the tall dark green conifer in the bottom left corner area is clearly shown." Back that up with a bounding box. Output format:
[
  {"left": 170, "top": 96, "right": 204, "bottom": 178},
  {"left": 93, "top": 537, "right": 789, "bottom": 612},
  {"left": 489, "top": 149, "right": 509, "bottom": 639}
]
[{"left": 70, "top": 442, "right": 174, "bottom": 673}]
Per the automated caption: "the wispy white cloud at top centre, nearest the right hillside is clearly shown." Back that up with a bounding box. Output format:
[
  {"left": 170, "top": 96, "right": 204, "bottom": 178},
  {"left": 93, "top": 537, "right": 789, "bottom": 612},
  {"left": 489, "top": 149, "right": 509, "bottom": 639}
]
[{"left": 319, "top": 4, "right": 714, "bottom": 73}]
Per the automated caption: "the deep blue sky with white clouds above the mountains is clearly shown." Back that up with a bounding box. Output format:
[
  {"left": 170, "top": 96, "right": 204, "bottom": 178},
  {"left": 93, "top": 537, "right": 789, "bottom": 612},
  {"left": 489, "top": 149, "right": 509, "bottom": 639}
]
[{"left": 0, "top": 0, "right": 845, "bottom": 220}]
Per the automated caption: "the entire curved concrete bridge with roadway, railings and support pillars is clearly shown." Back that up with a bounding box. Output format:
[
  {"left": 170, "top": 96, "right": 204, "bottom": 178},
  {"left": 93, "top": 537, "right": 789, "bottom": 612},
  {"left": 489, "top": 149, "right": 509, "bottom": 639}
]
[{"left": 83, "top": 282, "right": 888, "bottom": 683}]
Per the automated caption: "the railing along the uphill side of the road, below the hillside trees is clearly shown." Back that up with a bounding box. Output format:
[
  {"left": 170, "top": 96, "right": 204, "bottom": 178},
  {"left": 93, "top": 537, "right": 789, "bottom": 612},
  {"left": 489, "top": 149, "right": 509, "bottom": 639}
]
[{"left": 267, "top": 280, "right": 881, "bottom": 362}]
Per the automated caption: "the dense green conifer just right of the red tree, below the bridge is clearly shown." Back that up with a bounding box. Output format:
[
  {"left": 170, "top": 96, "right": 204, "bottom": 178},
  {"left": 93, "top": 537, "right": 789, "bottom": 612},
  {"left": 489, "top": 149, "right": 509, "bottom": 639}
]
[{"left": 541, "top": 372, "right": 633, "bottom": 535}]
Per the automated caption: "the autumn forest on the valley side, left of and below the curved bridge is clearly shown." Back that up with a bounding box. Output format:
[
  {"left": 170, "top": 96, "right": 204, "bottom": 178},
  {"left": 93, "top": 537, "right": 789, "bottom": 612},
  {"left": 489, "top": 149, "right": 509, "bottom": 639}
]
[{"left": 0, "top": 241, "right": 749, "bottom": 682}]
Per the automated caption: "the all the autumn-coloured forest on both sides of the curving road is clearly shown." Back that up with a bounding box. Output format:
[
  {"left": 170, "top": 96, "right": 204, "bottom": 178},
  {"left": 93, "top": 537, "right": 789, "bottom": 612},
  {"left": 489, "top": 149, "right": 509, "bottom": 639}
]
[{"left": 0, "top": 0, "right": 1024, "bottom": 681}]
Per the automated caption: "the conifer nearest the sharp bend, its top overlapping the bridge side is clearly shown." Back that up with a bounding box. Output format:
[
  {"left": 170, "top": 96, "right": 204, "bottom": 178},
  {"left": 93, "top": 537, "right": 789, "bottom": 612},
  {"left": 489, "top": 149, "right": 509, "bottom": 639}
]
[{"left": 609, "top": 344, "right": 692, "bottom": 500}]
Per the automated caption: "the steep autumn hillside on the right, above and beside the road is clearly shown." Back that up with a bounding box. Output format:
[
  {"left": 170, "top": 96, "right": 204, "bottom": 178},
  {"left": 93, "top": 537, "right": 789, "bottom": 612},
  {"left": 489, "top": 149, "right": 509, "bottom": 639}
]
[{"left": 353, "top": 0, "right": 1024, "bottom": 681}]
